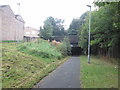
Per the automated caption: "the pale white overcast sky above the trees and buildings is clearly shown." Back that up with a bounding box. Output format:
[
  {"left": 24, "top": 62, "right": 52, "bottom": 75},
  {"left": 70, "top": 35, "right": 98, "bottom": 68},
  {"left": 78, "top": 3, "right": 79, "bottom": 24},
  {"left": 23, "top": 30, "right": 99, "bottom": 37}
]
[{"left": 0, "top": 0, "right": 94, "bottom": 29}]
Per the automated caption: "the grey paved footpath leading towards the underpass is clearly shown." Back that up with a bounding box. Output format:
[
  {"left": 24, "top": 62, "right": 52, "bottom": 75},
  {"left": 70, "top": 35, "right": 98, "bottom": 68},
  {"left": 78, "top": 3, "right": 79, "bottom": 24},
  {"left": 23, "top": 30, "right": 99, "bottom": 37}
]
[{"left": 35, "top": 56, "right": 80, "bottom": 88}]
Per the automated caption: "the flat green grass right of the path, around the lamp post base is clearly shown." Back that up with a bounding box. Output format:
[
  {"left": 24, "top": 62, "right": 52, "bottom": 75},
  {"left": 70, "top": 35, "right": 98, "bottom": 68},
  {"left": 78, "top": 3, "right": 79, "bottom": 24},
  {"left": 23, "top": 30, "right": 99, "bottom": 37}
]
[{"left": 80, "top": 56, "right": 118, "bottom": 88}]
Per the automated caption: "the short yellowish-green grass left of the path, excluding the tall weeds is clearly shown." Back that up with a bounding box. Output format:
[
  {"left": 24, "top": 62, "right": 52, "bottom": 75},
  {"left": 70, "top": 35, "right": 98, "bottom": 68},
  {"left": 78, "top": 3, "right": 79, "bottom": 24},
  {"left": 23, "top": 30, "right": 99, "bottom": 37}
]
[{"left": 2, "top": 43, "right": 67, "bottom": 88}]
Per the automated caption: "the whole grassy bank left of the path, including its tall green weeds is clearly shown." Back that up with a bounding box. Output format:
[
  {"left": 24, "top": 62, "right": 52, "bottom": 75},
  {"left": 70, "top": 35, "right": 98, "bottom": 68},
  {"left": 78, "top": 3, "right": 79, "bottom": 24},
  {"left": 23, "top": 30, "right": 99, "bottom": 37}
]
[{"left": 2, "top": 41, "right": 67, "bottom": 88}]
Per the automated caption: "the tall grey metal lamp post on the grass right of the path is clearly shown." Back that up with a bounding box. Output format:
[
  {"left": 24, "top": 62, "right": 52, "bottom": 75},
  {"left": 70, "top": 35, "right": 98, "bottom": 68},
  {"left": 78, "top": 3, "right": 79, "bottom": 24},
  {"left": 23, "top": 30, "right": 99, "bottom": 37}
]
[{"left": 87, "top": 5, "right": 91, "bottom": 64}]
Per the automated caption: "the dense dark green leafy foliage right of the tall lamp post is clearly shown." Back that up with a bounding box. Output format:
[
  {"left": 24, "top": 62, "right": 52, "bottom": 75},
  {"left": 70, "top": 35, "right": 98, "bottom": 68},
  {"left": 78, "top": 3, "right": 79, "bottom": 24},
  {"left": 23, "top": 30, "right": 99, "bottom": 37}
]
[{"left": 91, "top": 2, "right": 120, "bottom": 48}]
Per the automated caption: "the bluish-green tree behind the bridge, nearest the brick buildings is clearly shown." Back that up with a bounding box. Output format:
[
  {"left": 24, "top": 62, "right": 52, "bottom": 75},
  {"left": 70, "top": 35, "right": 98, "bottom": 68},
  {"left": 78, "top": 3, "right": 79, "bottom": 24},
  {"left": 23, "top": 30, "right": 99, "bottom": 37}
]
[{"left": 40, "top": 16, "right": 66, "bottom": 40}]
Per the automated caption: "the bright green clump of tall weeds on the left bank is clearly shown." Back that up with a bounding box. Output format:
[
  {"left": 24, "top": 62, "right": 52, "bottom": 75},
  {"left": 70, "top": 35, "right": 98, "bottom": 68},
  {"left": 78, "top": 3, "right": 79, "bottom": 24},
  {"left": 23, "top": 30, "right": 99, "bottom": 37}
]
[{"left": 18, "top": 39, "right": 62, "bottom": 58}]
